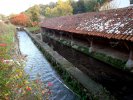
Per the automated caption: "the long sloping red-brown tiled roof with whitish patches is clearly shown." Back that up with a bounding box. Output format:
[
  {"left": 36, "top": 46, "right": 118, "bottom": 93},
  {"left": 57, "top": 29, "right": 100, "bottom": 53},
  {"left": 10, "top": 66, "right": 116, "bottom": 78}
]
[{"left": 41, "top": 7, "right": 133, "bottom": 42}]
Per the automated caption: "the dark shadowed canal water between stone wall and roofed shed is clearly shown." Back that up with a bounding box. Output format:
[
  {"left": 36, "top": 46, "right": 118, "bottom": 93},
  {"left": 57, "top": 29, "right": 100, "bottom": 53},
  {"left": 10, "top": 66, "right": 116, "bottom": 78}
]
[{"left": 43, "top": 35, "right": 133, "bottom": 100}]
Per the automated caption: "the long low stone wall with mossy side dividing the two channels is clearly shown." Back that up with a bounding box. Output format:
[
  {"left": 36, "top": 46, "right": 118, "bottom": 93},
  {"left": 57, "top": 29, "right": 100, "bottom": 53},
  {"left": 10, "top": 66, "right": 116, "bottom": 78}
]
[{"left": 24, "top": 29, "right": 115, "bottom": 100}]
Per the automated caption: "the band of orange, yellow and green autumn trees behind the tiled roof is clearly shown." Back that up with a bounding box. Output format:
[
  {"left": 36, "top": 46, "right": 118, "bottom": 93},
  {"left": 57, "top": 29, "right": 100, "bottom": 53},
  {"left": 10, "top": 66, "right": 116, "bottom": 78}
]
[{"left": 6, "top": 0, "right": 110, "bottom": 27}]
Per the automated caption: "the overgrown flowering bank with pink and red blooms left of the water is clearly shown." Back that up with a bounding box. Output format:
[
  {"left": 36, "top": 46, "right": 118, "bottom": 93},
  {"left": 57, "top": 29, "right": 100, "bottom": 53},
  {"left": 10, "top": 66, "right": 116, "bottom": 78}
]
[{"left": 0, "top": 23, "right": 48, "bottom": 100}]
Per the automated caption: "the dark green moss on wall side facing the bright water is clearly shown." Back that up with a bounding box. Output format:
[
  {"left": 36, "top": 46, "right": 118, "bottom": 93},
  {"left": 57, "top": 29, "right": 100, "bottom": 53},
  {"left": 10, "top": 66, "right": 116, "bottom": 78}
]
[{"left": 41, "top": 50, "right": 87, "bottom": 100}]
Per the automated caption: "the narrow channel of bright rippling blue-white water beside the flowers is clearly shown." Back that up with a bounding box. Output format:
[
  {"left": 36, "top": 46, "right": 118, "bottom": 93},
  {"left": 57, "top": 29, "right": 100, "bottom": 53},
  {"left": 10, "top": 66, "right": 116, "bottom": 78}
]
[{"left": 18, "top": 31, "right": 79, "bottom": 100}]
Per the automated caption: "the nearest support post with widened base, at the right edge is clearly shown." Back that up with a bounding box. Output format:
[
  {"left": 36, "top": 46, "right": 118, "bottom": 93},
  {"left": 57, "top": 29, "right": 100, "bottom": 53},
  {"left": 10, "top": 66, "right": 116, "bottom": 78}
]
[{"left": 126, "top": 45, "right": 133, "bottom": 69}]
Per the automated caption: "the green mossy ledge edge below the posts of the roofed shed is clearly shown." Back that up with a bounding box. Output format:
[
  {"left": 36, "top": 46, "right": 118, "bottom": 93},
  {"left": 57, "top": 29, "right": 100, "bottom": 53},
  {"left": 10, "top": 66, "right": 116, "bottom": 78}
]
[{"left": 43, "top": 35, "right": 126, "bottom": 70}]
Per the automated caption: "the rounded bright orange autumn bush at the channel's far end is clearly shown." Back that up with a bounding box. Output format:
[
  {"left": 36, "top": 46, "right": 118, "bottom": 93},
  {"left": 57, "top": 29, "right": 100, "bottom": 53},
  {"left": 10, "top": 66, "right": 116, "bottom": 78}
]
[{"left": 10, "top": 13, "right": 30, "bottom": 26}]
